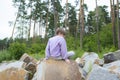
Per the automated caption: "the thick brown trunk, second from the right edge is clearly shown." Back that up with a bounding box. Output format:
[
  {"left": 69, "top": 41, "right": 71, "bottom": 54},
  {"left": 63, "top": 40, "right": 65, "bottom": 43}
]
[{"left": 110, "top": 0, "right": 116, "bottom": 47}]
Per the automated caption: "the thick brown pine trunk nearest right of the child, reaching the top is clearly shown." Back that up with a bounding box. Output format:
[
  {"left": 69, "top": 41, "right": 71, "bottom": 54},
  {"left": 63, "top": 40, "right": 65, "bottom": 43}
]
[{"left": 80, "top": 0, "right": 84, "bottom": 49}]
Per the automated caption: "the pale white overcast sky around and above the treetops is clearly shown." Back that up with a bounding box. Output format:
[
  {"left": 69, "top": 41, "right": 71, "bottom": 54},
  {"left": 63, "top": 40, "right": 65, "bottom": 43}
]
[{"left": 0, "top": 0, "right": 110, "bottom": 39}]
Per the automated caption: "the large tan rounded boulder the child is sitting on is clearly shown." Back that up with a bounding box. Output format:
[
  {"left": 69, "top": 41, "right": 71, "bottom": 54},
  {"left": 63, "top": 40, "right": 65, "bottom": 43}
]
[{"left": 33, "top": 59, "right": 81, "bottom": 80}]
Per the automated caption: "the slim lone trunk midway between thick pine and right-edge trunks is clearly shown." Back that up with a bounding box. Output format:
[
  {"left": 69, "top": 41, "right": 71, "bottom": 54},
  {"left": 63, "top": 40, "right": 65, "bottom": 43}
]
[{"left": 96, "top": 0, "right": 100, "bottom": 52}]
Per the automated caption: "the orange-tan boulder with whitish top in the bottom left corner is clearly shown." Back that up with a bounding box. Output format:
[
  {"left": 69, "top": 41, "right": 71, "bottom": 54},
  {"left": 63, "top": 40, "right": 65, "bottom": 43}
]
[{"left": 0, "top": 61, "right": 28, "bottom": 80}]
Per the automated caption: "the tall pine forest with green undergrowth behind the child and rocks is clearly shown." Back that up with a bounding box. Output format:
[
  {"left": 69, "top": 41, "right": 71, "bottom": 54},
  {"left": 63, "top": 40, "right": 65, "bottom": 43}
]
[{"left": 0, "top": 0, "right": 120, "bottom": 62}]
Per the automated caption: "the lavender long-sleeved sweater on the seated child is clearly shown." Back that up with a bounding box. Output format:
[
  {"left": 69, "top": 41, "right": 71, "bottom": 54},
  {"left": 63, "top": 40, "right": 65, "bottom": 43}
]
[{"left": 45, "top": 36, "right": 67, "bottom": 59}]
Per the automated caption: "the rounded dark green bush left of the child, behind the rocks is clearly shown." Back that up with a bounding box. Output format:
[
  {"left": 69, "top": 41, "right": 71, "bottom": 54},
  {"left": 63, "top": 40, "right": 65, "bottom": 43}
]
[{"left": 9, "top": 42, "right": 26, "bottom": 59}]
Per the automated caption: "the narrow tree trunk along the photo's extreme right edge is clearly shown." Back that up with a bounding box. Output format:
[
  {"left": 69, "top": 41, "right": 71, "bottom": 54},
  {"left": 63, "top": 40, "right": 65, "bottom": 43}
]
[{"left": 117, "top": 0, "right": 120, "bottom": 49}]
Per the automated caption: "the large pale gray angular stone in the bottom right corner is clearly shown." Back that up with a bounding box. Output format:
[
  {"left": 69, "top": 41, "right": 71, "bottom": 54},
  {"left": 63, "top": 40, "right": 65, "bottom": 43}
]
[{"left": 86, "top": 65, "right": 120, "bottom": 80}]
